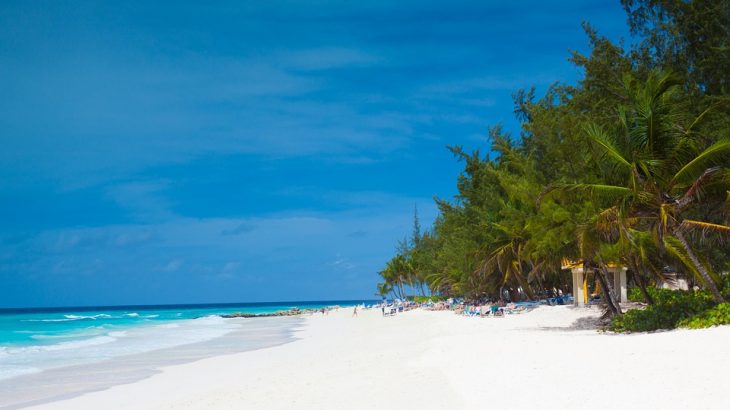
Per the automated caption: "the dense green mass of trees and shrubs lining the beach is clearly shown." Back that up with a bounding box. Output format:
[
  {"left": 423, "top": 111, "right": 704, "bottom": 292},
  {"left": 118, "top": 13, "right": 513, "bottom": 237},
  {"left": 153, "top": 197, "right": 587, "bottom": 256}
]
[{"left": 378, "top": 0, "right": 730, "bottom": 304}]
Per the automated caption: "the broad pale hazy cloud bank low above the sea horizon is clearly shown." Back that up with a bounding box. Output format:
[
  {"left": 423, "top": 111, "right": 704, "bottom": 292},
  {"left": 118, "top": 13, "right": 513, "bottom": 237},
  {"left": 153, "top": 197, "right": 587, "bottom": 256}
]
[{"left": 0, "top": 192, "right": 435, "bottom": 303}]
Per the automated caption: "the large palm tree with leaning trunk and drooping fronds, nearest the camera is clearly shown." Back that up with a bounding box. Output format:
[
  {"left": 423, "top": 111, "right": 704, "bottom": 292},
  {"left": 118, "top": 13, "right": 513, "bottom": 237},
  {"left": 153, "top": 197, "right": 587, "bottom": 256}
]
[{"left": 567, "top": 72, "right": 730, "bottom": 302}]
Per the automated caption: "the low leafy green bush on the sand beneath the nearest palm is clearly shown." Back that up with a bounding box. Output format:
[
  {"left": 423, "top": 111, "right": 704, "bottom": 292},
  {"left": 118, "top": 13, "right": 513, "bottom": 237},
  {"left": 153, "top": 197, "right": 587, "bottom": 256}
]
[{"left": 609, "top": 288, "right": 716, "bottom": 332}]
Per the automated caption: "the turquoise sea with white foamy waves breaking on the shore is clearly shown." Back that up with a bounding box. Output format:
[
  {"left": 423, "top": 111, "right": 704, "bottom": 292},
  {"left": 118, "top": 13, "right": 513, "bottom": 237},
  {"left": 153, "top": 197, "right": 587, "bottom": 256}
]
[{"left": 0, "top": 301, "right": 372, "bottom": 380}]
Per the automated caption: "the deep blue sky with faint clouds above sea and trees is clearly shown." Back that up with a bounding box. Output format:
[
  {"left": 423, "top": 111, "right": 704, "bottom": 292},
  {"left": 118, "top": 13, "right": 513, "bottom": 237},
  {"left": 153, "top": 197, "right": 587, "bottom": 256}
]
[{"left": 0, "top": 0, "right": 628, "bottom": 307}]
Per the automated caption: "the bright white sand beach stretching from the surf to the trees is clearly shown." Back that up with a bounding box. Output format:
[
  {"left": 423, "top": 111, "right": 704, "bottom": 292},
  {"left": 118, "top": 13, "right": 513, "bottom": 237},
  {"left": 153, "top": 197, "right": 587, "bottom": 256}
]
[{"left": 27, "top": 306, "right": 730, "bottom": 410}]
